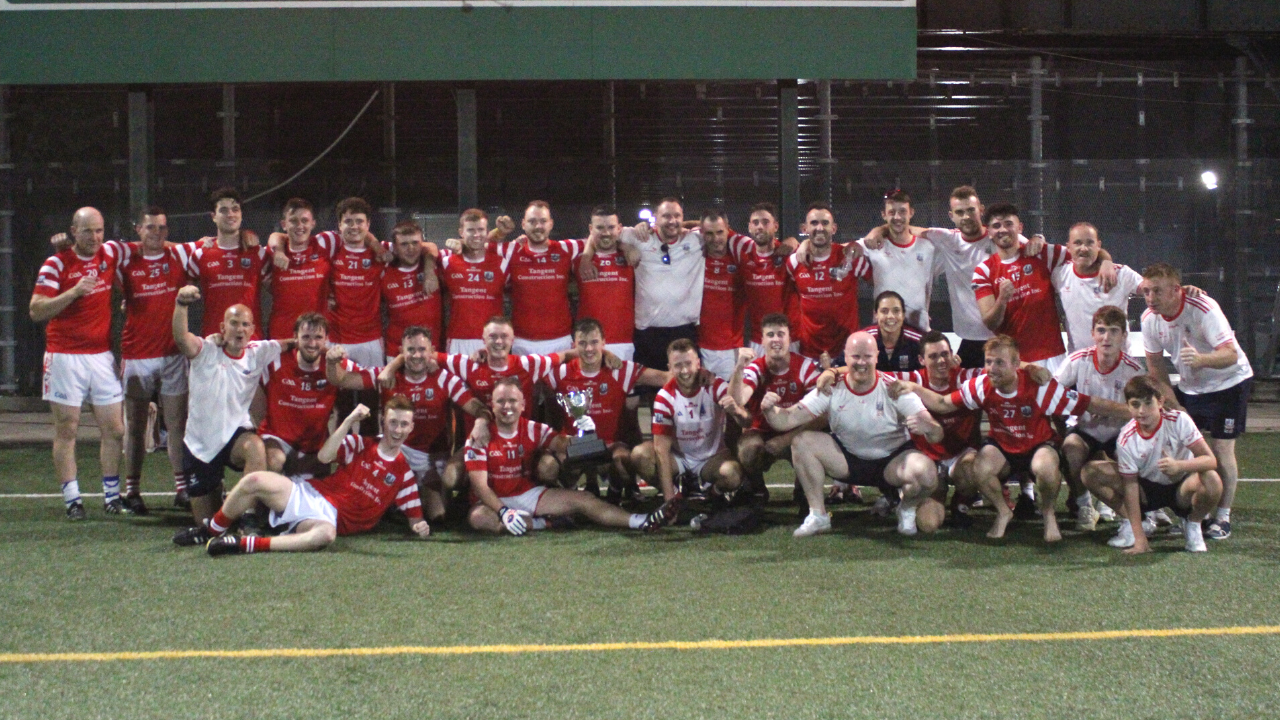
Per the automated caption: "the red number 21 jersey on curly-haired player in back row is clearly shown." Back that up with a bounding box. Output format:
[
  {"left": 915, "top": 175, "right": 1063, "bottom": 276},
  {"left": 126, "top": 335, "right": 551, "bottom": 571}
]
[{"left": 316, "top": 231, "right": 385, "bottom": 345}]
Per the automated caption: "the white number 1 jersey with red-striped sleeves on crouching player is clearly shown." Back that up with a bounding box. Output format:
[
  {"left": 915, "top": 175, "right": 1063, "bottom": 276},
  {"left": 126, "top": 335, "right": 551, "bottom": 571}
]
[{"left": 653, "top": 378, "right": 728, "bottom": 466}]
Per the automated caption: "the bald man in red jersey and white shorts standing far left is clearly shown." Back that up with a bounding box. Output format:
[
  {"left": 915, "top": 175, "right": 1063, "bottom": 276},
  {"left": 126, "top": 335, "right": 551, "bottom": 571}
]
[{"left": 29, "top": 208, "right": 124, "bottom": 520}]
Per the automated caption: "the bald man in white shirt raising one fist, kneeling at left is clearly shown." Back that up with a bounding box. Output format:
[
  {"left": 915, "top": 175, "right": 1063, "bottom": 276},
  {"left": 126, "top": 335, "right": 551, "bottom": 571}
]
[{"left": 173, "top": 286, "right": 293, "bottom": 546}]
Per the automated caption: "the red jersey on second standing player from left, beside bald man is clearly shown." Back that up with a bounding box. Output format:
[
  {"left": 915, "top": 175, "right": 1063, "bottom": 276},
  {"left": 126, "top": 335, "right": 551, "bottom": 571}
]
[{"left": 115, "top": 242, "right": 187, "bottom": 360}]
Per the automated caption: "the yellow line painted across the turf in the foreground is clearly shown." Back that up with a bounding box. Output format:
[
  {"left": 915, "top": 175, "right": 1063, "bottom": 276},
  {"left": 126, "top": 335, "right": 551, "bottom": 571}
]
[{"left": 0, "top": 625, "right": 1280, "bottom": 662}]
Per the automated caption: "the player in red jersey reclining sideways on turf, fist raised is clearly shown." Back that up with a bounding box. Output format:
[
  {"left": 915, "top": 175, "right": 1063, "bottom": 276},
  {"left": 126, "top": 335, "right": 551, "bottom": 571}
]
[{"left": 207, "top": 396, "right": 431, "bottom": 557}]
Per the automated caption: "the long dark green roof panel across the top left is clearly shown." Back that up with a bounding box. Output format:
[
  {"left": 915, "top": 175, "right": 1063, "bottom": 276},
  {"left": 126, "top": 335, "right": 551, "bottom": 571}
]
[{"left": 0, "top": 0, "right": 916, "bottom": 85}]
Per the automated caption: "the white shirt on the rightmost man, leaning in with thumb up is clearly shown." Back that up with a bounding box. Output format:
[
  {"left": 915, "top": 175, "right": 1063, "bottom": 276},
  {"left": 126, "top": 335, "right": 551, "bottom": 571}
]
[{"left": 1142, "top": 295, "right": 1253, "bottom": 395}]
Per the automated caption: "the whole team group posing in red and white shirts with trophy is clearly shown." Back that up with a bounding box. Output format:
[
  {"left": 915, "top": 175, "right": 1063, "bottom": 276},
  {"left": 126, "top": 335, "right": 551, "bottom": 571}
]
[{"left": 29, "top": 186, "right": 1253, "bottom": 556}]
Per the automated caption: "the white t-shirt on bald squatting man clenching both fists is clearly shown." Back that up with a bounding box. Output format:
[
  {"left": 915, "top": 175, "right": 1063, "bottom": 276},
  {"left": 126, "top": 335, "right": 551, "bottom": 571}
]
[{"left": 800, "top": 373, "right": 924, "bottom": 460}]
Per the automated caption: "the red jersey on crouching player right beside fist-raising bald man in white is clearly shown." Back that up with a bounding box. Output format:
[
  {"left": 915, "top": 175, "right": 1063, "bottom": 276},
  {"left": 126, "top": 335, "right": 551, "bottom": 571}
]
[{"left": 257, "top": 350, "right": 378, "bottom": 454}]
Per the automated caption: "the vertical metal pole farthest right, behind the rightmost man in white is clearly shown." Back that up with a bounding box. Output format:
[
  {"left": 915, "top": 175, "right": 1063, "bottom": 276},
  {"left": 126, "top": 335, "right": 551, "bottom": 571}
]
[{"left": 1229, "top": 56, "right": 1253, "bottom": 356}]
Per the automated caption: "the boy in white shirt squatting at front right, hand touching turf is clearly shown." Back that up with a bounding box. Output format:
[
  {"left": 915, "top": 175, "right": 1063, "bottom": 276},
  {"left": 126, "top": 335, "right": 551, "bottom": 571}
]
[{"left": 1080, "top": 375, "right": 1222, "bottom": 553}]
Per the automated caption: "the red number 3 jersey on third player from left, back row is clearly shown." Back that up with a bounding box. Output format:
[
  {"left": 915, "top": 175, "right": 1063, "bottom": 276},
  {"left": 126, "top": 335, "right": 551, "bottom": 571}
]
[{"left": 170, "top": 242, "right": 271, "bottom": 340}]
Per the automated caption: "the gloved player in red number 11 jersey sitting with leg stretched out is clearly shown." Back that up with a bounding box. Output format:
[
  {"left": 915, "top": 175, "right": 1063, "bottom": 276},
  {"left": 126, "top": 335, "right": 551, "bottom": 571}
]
[{"left": 466, "top": 377, "right": 677, "bottom": 536}]
